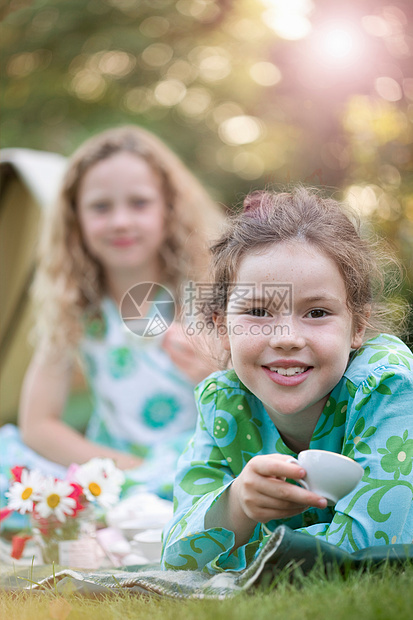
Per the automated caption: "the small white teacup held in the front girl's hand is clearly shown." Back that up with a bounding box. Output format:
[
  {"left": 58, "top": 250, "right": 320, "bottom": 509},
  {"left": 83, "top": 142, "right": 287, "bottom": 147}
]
[{"left": 291, "top": 450, "right": 364, "bottom": 506}]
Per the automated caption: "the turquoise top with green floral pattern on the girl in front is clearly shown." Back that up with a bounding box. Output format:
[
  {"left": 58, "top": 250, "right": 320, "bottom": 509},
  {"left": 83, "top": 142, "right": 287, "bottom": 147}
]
[{"left": 162, "top": 334, "right": 413, "bottom": 574}]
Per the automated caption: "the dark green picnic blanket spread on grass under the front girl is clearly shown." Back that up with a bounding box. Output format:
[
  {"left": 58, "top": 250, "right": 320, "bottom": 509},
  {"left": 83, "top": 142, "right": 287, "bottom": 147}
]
[{"left": 0, "top": 526, "right": 413, "bottom": 599}]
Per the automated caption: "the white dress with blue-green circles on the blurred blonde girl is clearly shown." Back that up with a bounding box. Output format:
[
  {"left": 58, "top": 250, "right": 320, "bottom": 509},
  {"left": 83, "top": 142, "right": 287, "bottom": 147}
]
[{"left": 0, "top": 298, "right": 197, "bottom": 527}]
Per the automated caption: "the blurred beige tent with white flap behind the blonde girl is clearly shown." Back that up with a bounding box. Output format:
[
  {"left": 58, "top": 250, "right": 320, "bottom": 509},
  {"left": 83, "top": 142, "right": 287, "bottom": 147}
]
[{"left": 0, "top": 148, "right": 66, "bottom": 424}]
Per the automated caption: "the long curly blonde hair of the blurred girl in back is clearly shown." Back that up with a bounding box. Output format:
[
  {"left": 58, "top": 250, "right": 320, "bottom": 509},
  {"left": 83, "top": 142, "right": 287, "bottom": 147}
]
[{"left": 32, "top": 126, "right": 223, "bottom": 354}]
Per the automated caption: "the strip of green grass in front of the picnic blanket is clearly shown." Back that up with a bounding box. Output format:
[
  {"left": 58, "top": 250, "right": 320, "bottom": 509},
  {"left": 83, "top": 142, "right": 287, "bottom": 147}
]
[{"left": 0, "top": 566, "right": 413, "bottom": 620}]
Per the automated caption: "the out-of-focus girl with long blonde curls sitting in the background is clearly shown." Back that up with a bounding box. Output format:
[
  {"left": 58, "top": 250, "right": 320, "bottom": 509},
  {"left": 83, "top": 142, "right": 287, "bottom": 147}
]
[{"left": 2, "top": 126, "right": 222, "bottom": 508}]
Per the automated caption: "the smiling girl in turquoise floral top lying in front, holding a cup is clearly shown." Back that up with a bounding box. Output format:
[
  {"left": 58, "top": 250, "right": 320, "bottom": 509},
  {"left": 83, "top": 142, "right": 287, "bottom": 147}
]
[{"left": 163, "top": 188, "right": 413, "bottom": 573}]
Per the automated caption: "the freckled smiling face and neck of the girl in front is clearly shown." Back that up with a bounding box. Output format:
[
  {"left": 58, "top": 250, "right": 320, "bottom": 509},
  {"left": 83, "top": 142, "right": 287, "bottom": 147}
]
[{"left": 220, "top": 241, "right": 364, "bottom": 432}]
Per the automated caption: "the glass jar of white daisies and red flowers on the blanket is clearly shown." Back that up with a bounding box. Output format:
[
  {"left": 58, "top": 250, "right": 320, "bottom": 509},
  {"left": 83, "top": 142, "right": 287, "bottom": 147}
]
[{"left": 6, "top": 458, "right": 124, "bottom": 568}]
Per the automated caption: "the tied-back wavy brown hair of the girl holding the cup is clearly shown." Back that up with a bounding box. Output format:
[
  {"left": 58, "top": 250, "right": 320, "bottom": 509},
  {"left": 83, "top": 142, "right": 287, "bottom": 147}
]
[{"left": 204, "top": 186, "right": 407, "bottom": 354}]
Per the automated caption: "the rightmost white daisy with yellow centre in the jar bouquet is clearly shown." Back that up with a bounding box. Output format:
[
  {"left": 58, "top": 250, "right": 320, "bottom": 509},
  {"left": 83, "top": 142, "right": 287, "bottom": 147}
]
[{"left": 75, "top": 458, "right": 125, "bottom": 508}]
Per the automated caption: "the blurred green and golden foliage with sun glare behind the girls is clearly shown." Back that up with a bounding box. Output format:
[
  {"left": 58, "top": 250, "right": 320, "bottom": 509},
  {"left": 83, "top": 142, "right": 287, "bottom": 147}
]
[{"left": 0, "top": 0, "right": 413, "bottom": 338}]
